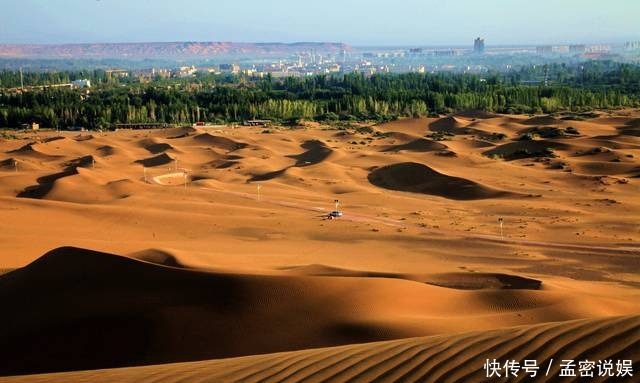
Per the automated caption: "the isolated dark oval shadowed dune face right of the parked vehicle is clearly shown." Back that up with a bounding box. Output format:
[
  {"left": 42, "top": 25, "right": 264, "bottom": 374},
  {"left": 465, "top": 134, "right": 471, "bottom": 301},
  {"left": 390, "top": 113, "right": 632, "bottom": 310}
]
[{"left": 369, "top": 162, "right": 515, "bottom": 200}]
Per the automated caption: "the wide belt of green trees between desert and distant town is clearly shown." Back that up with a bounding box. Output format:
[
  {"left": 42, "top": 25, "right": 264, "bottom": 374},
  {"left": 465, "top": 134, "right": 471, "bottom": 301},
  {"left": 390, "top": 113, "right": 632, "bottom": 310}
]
[{"left": 0, "top": 62, "right": 640, "bottom": 130}]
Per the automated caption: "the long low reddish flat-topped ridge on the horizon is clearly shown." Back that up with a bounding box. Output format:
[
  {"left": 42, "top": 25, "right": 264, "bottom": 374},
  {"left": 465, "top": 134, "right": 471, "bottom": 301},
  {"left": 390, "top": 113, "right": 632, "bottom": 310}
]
[{"left": 0, "top": 41, "right": 350, "bottom": 59}]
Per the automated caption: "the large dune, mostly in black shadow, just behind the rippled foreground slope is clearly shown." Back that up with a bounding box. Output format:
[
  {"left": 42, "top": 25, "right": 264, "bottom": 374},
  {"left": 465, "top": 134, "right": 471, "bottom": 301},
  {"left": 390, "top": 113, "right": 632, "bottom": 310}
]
[{"left": 0, "top": 247, "right": 636, "bottom": 375}]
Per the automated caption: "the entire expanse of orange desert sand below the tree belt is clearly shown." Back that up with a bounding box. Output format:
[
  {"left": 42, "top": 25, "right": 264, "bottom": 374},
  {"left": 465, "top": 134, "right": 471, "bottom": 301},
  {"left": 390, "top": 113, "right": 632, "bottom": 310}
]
[{"left": 0, "top": 110, "right": 640, "bottom": 382}]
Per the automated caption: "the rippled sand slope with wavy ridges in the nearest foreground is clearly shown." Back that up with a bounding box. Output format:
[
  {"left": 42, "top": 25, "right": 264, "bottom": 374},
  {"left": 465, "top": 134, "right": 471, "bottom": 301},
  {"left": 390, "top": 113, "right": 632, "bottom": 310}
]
[{"left": 3, "top": 316, "right": 640, "bottom": 383}]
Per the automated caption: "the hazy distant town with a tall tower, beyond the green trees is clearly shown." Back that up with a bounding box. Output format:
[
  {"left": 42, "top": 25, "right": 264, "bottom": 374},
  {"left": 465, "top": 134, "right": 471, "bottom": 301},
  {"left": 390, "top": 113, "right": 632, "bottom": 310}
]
[{"left": 76, "top": 37, "right": 640, "bottom": 82}]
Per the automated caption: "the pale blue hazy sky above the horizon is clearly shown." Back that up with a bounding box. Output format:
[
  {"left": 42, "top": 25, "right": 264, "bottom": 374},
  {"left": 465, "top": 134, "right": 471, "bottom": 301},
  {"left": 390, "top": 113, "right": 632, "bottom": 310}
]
[{"left": 0, "top": 0, "right": 640, "bottom": 45}]
